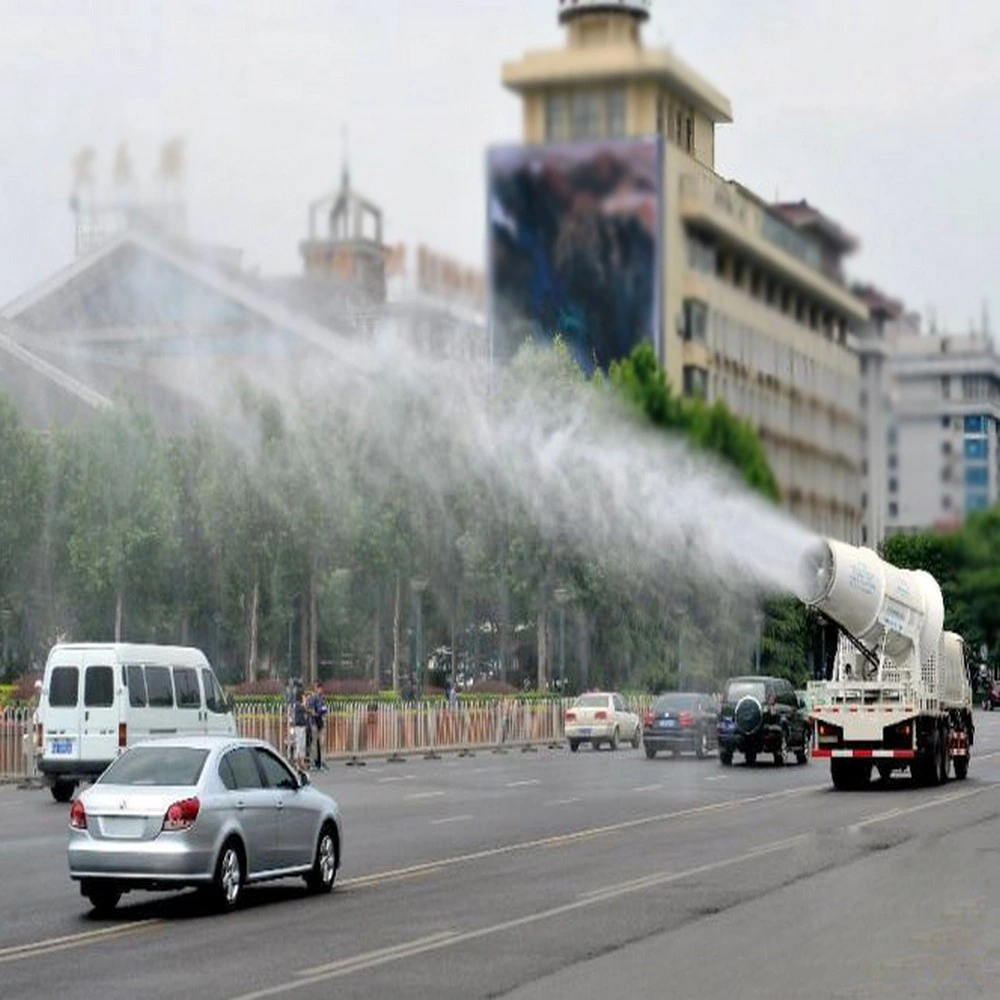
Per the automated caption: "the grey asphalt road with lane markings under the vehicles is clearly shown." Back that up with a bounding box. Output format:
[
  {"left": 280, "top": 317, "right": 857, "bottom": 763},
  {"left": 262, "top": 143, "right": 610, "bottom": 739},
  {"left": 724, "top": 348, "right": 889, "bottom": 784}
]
[{"left": 0, "top": 712, "right": 1000, "bottom": 1000}]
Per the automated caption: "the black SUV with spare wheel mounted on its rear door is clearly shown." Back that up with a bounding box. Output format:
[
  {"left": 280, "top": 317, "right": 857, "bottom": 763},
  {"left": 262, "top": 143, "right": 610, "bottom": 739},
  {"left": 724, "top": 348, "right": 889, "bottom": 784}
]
[{"left": 718, "top": 677, "right": 811, "bottom": 767}]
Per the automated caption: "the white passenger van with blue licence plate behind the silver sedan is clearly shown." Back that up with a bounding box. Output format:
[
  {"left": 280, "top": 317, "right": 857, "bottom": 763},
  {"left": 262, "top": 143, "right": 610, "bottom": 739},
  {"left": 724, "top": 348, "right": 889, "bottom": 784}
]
[{"left": 35, "top": 642, "right": 236, "bottom": 802}]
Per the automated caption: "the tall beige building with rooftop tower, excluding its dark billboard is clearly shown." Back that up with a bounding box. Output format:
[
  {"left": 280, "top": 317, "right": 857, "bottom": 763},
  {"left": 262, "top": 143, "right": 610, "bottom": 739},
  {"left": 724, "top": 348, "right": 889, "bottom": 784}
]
[{"left": 503, "top": 0, "right": 868, "bottom": 542}]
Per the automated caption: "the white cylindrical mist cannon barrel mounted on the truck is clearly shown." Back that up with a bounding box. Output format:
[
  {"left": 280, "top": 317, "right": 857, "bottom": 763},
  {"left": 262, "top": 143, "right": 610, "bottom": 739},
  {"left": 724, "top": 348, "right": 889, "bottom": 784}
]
[{"left": 799, "top": 539, "right": 944, "bottom": 683}]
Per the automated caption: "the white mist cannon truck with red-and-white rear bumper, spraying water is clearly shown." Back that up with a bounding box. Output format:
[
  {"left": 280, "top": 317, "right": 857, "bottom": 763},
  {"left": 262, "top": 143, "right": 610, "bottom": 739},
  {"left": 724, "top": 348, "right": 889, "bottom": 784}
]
[{"left": 799, "top": 540, "right": 974, "bottom": 790}]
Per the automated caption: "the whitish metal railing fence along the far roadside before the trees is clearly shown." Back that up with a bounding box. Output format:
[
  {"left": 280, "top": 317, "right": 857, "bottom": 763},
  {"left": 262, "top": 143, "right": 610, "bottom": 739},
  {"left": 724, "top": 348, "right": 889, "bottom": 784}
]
[{"left": 0, "top": 696, "right": 652, "bottom": 780}]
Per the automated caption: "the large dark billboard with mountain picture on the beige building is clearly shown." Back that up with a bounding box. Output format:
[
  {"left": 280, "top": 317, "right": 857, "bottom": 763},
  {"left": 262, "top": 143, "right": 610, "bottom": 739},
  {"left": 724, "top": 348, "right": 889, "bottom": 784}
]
[{"left": 487, "top": 137, "right": 663, "bottom": 372}]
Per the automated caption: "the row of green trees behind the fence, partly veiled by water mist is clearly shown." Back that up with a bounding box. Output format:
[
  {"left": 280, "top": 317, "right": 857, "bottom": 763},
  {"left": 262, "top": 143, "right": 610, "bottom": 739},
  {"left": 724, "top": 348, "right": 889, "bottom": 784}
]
[{"left": 0, "top": 342, "right": 812, "bottom": 691}]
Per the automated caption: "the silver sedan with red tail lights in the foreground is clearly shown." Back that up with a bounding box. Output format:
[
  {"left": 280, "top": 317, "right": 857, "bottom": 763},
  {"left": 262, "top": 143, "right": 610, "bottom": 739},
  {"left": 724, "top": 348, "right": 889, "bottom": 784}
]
[{"left": 68, "top": 736, "right": 343, "bottom": 911}]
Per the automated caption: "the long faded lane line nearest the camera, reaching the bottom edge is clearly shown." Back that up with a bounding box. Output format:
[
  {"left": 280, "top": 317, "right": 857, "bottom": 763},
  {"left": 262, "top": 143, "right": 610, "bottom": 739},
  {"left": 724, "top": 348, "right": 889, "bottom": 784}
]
[{"left": 229, "top": 834, "right": 809, "bottom": 1000}]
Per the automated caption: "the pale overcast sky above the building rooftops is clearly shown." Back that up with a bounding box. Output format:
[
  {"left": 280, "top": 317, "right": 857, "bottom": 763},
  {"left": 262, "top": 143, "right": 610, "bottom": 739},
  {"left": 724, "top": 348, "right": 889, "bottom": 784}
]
[{"left": 0, "top": 0, "right": 1000, "bottom": 329}]
